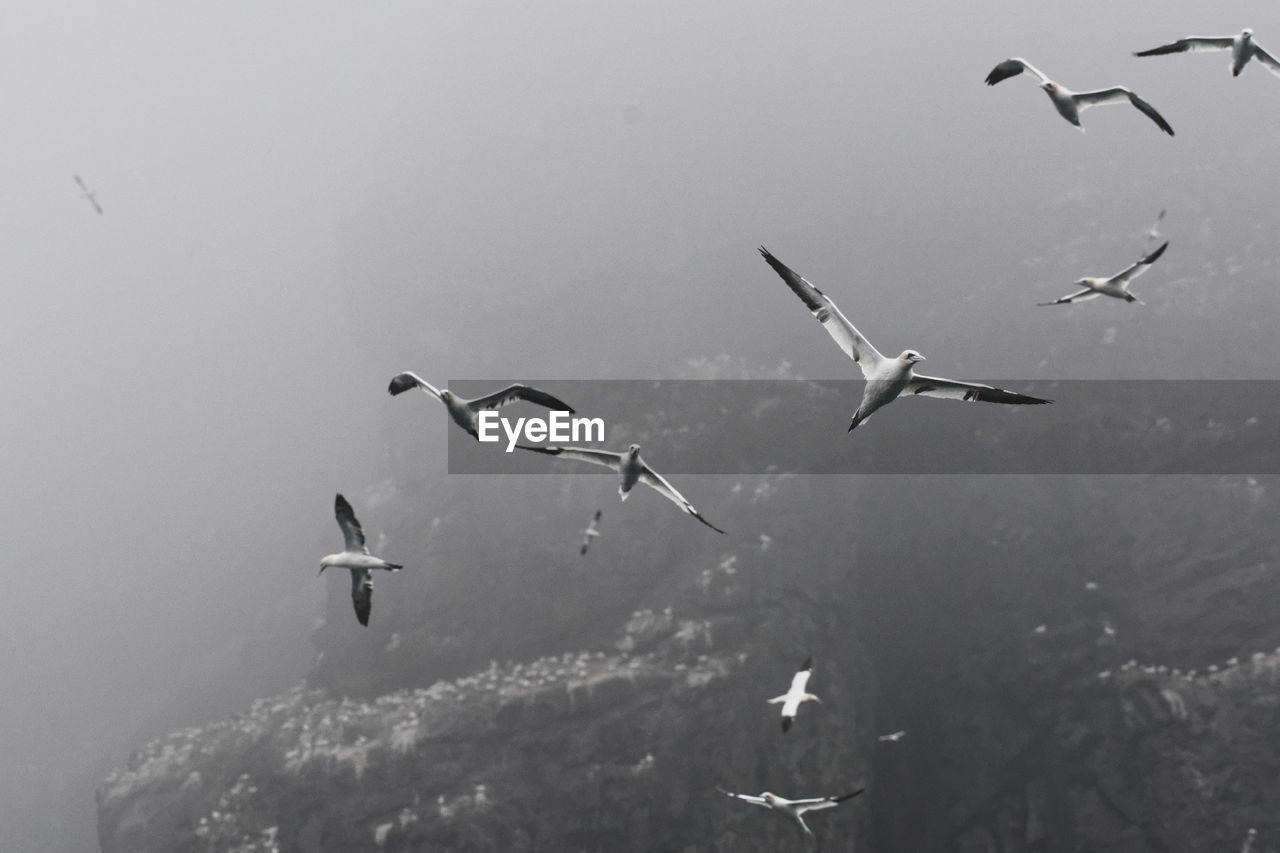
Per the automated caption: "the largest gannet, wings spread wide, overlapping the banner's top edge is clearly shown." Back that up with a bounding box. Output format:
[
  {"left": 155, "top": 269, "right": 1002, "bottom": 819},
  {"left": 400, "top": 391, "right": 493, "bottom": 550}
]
[{"left": 760, "top": 246, "right": 1052, "bottom": 430}]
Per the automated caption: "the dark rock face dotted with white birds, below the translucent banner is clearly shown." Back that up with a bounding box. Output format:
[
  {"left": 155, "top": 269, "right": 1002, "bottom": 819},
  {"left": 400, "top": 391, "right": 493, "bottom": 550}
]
[{"left": 99, "top": 376, "right": 1280, "bottom": 853}]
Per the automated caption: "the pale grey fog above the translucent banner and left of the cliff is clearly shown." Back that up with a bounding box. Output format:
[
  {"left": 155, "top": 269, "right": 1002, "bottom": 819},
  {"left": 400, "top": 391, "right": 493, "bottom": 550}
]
[{"left": 0, "top": 1, "right": 1280, "bottom": 850}]
